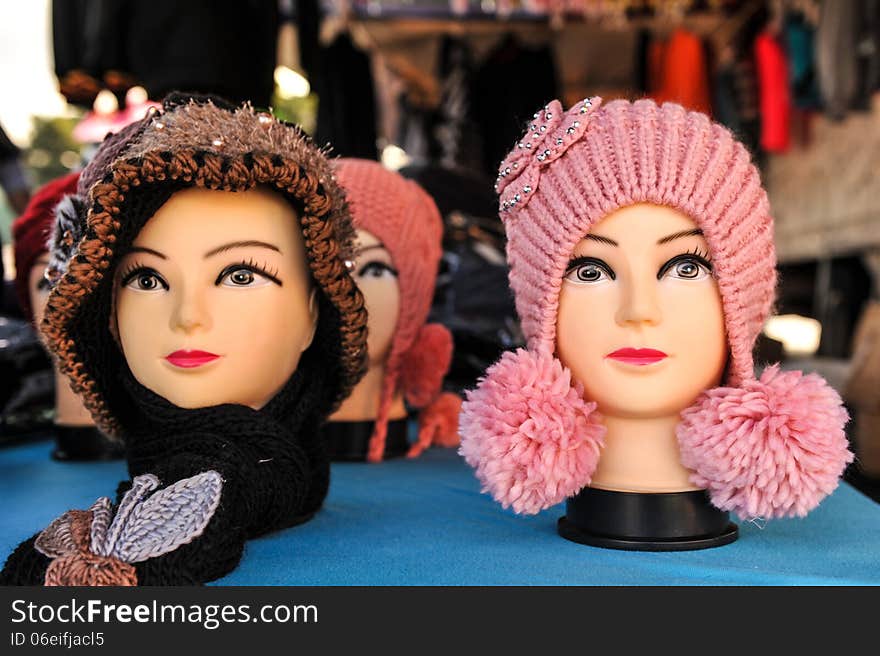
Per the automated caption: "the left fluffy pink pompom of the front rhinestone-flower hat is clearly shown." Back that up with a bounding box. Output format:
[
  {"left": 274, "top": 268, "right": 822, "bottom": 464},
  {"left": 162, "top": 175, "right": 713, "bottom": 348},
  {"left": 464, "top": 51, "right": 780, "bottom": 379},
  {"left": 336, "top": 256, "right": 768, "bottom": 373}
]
[{"left": 459, "top": 349, "right": 605, "bottom": 514}]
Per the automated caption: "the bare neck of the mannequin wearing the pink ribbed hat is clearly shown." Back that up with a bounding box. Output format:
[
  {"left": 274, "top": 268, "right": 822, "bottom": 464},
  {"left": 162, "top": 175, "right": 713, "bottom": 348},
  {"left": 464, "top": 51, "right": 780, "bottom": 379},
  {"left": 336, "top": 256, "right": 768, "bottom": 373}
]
[{"left": 590, "top": 415, "right": 699, "bottom": 493}]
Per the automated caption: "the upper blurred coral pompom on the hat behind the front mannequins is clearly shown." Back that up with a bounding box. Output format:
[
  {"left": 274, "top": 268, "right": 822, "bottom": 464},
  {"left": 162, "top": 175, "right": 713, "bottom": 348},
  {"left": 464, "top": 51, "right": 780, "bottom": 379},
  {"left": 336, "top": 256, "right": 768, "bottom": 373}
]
[{"left": 400, "top": 323, "right": 452, "bottom": 408}]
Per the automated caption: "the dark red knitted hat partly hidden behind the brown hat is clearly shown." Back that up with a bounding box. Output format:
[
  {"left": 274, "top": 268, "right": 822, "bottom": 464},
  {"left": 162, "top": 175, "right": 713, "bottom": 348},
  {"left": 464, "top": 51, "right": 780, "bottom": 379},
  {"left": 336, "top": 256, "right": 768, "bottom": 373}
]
[{"left": 12, "top": 173, "right": 79, "bottom": 322}]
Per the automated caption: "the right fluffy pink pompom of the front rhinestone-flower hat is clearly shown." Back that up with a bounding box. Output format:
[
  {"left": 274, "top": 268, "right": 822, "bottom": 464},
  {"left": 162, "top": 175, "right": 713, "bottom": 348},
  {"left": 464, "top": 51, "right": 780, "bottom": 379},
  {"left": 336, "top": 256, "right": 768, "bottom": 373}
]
[{"left": 677, "top": 365, "right": 853, "bottom": 518}]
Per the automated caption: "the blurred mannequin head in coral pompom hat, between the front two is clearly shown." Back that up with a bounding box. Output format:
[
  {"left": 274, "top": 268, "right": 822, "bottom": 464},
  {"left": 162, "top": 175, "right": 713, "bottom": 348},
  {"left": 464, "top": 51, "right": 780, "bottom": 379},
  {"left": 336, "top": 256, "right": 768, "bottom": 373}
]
[{"left": 332, "top": 159, "right": 460, "bottom": 461}]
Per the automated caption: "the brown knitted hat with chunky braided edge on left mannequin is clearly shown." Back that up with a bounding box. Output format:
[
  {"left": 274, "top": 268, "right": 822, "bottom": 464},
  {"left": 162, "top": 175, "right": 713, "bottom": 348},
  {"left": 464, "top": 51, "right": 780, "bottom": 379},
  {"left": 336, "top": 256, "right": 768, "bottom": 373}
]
[{"left": 41, "top": 95, "right": 367, "bottom": 435}]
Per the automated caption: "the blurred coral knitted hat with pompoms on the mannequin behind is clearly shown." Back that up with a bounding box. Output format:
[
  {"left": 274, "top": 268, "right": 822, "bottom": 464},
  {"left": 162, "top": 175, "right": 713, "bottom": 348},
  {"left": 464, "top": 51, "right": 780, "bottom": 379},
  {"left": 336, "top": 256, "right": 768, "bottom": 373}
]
[{"left": 334, "top": 159, "right": 461, "bottom": 462}]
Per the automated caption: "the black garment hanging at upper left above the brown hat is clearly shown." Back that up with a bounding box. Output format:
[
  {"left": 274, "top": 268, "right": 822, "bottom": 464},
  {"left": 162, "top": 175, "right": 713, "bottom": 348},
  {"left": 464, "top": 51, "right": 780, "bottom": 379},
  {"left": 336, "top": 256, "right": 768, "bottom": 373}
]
[{"left": 52, "top": 0, "right": 278, "bottom": 107}]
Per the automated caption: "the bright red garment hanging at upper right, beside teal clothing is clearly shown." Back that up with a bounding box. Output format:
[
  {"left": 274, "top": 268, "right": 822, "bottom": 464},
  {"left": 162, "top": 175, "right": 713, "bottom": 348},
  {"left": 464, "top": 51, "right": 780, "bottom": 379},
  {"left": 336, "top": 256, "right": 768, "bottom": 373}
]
[{"left": 754, "top": 32, "right": 791, "bottom": 153}]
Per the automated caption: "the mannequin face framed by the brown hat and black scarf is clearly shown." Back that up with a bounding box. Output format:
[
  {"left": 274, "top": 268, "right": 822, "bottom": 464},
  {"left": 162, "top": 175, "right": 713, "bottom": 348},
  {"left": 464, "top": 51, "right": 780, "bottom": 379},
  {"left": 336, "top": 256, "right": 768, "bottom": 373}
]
[{"left": 114, "top": 188, "right": 317, "bottom": 409}]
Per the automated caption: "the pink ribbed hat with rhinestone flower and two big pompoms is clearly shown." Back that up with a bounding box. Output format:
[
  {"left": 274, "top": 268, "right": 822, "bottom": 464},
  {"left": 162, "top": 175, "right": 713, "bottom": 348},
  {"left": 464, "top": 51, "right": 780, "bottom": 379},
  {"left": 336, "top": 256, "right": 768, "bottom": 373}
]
[{"left": 460, "top": 98, "right": 853, "bottom": 517}]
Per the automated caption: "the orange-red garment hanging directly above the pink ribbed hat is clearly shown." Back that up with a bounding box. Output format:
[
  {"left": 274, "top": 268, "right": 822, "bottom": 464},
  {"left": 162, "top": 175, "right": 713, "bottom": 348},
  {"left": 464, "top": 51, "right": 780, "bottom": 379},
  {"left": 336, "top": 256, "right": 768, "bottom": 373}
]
[{"left": 649, "top": 27, "right": 712, "bottom": 116}]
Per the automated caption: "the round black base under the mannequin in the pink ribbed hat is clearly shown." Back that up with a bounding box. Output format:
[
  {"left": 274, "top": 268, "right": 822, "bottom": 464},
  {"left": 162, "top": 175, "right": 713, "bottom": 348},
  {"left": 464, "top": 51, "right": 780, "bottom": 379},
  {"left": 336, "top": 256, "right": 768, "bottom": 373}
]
[{"left": 557, "top": 487, "right": 739, "bottom": 551}]
